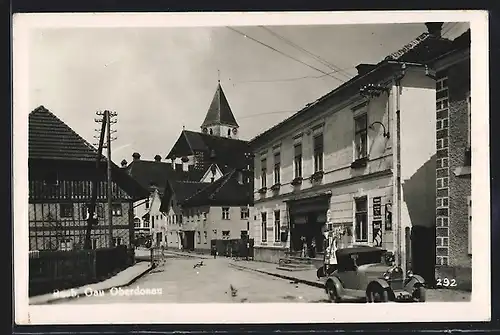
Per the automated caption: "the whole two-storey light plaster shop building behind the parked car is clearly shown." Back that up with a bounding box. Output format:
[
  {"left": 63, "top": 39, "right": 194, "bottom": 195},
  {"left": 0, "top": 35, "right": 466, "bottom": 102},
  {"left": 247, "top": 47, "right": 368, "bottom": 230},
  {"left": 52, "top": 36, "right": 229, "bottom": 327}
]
[{"left": 250, "top": 23, "right": 451, "bottom": 284}]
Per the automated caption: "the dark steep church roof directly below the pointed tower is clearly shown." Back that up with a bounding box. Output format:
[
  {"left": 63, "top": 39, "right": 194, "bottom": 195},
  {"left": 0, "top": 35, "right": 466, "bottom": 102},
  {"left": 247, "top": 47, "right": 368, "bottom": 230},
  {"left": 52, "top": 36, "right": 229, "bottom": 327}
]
[{"left": 167, "top": 130, "right": 252, "bottom": 172}]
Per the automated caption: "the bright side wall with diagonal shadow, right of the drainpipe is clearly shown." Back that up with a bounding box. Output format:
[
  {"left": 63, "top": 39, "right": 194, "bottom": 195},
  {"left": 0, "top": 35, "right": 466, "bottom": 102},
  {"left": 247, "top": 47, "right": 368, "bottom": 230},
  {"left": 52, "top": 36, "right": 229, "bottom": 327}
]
[{"left": 393, "top": 70, "right": 436, "bottom": 265}]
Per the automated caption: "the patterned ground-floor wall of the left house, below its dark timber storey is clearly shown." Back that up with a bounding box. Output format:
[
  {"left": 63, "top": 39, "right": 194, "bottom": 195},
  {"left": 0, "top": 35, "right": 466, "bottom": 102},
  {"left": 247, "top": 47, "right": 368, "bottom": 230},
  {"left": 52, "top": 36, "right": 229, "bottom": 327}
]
[{"left": 29, "top": 202, "right": 132, "bottom": 250}]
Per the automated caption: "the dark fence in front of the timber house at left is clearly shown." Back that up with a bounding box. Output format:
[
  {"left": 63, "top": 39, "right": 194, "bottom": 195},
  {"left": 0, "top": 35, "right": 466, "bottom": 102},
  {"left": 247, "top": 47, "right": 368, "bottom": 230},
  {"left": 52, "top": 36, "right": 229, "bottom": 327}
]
[{"left": 29, "top": 246, "right": 134, "bottom": 296}]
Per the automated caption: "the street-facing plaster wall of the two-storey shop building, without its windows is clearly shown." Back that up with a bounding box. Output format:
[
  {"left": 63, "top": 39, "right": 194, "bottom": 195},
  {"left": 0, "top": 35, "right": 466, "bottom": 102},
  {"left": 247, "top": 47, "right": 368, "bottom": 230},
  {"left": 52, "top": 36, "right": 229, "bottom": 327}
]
[{"left": 251, "top": 80, "right": 394, "bottom": 263}]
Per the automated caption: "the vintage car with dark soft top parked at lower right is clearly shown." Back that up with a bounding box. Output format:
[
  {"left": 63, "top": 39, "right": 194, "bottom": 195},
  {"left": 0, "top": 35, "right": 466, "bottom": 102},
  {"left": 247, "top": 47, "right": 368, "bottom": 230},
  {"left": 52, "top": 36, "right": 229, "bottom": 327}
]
[{"left": 324, "top": 246, "right": 425, "bottom": 302}]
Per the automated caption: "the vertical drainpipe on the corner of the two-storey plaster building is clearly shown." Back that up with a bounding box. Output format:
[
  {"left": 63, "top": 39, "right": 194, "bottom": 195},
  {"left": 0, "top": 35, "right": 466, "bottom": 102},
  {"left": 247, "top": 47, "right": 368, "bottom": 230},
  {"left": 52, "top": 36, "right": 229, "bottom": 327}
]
[{"left": 394, "top": 63, "right": 406, "bottom": 272}]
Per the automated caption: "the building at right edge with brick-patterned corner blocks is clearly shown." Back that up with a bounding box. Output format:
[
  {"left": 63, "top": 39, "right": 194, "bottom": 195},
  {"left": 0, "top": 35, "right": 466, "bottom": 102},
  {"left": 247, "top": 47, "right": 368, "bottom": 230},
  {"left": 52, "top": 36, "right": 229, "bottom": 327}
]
[{"left": 434, "top": 31, "right": 472, "bottom": 289}]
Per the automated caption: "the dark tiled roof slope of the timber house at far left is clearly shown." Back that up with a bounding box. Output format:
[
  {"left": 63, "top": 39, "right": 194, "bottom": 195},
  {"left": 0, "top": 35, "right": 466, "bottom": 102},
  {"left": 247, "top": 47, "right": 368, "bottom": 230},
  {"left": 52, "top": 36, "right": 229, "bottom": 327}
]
[{"left": 28, "top": 106, "right": 102, "bottom": 161}]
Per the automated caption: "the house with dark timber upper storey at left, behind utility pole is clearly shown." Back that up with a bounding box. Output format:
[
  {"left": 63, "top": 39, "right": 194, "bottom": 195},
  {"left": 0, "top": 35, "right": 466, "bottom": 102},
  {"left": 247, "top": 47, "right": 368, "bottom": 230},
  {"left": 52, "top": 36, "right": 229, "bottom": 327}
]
[{"left": 28, "top": 106, "right": 147, "bottom": 250}]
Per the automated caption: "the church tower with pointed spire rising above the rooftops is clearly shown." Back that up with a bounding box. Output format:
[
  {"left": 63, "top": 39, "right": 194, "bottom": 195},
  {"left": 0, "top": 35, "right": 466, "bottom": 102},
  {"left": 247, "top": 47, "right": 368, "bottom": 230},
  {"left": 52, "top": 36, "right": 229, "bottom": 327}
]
[{"left": 201, "top": 81, "right": 239, "bottom": 139}]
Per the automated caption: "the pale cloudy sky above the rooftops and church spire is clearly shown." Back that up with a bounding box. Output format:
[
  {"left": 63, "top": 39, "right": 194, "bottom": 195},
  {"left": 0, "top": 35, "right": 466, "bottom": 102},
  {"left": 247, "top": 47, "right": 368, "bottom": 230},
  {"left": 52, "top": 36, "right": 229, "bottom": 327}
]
[{"left": 29, "top": 23, "right": 469, "bottom": 163}]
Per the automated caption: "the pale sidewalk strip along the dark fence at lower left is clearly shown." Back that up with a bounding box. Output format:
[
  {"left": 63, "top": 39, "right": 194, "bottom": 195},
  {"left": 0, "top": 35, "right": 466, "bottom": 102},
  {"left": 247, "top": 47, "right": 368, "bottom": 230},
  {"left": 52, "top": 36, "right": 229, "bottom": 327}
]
[{"left": 29, "top": 262, "right": 151, "bottom": 305}]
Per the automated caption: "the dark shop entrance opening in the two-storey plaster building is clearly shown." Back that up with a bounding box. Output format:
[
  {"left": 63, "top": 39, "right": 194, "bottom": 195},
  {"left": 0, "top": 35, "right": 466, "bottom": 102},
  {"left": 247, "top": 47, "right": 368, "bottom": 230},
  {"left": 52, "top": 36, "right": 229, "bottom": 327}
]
[{"left": 288, "top": 195, "right": 330, "bottom": 257}]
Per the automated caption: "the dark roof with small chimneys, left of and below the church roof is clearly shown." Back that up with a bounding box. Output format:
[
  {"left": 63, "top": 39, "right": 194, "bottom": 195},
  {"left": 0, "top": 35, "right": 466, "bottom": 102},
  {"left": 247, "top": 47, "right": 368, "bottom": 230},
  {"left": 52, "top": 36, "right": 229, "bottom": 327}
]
[{"left": 125, "top": 160, "right": 203, "bottom": 195}]
